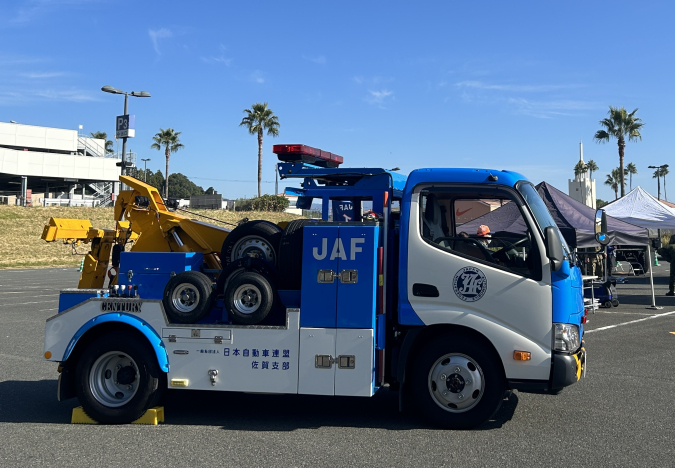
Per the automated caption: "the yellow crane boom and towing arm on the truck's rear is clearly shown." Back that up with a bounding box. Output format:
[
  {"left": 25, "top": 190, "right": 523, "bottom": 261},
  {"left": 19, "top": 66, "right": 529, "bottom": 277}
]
[{"left": 42, "top": 176, "right": 230, "bottom": 289}]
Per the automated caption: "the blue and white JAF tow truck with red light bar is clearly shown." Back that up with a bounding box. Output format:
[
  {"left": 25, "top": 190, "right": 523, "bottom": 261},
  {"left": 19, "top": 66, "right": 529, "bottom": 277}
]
[{"left": 44, "top": 145, "right": 586, "bottom": 428}]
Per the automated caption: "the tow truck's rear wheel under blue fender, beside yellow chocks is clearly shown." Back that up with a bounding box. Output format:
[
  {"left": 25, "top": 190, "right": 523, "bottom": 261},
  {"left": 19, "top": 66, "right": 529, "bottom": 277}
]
[{"left": 75, "top": 332, "right": 164, "bottom": 424}]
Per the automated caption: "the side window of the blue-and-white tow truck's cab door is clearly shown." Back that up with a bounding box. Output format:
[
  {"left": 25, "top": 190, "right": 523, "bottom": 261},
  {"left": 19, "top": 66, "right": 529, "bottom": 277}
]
[{"left": 420, "top": 189, "right": 541, "bottom": 280}]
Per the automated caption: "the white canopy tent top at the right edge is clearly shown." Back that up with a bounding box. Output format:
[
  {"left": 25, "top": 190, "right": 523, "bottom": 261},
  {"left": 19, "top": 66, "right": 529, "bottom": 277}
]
[{"left": 603, "top": 186, "right": 675, "bottom": 229}]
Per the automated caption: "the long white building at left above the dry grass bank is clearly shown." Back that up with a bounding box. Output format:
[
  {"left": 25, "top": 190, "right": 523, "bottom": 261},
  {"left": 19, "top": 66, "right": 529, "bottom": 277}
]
[{"left": 0, "top": 122, "right": 126, "bottom": 205}]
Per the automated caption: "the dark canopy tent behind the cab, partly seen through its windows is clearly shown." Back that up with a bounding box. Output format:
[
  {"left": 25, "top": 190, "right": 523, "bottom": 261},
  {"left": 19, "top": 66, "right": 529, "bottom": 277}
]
[{"left": 457, "top": 182, "right": 649, "bottom": 249}]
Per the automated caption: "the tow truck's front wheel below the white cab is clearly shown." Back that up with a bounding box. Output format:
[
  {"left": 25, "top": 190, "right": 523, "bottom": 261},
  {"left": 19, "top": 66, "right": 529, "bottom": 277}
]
[{"left": 411, "top": 335, "right": 506, "bottom": 429}]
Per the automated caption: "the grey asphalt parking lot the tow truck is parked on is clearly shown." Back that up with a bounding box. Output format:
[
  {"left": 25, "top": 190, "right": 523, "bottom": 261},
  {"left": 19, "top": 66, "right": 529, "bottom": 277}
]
[{"left": 0, "top": 262, "right": 675, "bottom": 467}]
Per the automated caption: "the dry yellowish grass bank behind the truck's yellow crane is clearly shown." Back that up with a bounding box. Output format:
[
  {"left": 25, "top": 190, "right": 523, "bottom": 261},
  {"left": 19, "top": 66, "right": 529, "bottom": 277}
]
[{"left": 0, "top": 205, "right": 298, "bottom": 269}]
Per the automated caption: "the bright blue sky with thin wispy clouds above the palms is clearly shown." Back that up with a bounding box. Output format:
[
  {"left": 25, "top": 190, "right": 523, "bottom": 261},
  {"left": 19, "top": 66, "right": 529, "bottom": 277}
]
[{"left": 0, "top": 0, "right": 675, "bottom": 200}]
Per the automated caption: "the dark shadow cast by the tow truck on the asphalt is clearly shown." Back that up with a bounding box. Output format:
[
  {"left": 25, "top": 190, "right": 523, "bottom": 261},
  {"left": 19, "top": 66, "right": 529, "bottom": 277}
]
[{"left": 0, "top": 380, "right": 518, "bottom": 432}]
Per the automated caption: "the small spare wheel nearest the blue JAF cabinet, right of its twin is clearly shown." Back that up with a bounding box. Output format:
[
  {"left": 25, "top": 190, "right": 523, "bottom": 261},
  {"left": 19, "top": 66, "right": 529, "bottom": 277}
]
[{"left": 225, "top": 271, "right": 274, "bottom": 325}]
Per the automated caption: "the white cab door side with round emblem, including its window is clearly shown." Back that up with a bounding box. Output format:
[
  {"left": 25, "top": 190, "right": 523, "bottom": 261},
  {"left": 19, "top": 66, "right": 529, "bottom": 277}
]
[{"left": 407, "top": 185, "right": 552, "bottom": 380}]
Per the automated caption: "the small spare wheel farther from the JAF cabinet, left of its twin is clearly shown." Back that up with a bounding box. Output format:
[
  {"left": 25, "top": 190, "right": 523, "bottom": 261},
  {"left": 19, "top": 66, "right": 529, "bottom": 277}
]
[{"left": 162, "top": 271, "right": 213, "bottom": 323}]
